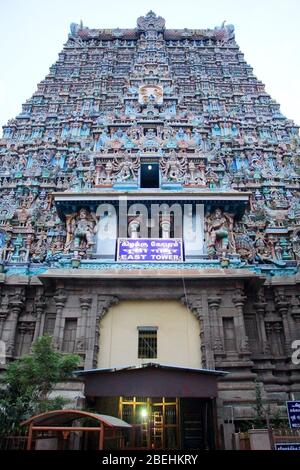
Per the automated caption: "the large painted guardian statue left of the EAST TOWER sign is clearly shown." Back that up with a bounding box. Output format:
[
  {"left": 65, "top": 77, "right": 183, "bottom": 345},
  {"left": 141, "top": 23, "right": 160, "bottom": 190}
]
[{"left": 64, "top": 208, "right": 98, "bottom": 252}]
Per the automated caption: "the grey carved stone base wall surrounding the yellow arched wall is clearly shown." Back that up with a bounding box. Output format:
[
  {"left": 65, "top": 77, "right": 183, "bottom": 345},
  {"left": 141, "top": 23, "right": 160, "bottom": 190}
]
[{"left": 0, "top": 272, "right": 300, "bottom": 419}]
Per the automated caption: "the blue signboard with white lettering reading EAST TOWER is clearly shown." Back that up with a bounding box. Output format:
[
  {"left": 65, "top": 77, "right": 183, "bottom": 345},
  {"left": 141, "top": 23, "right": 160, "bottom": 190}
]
[{"left": 117, "top": 238, "right": 183, "bottom": 263}]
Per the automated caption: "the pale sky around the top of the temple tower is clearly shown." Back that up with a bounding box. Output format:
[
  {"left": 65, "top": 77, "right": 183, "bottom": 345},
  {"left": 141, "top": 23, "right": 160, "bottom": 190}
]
[{"left": 0, "top": 0, "right": 300, "bottom": 130}]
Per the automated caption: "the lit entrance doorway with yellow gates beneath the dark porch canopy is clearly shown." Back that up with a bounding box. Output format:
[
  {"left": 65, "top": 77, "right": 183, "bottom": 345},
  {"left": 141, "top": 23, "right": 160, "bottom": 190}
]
[{"left": 90, "top": 396, "right": 216, "bottom": 450}]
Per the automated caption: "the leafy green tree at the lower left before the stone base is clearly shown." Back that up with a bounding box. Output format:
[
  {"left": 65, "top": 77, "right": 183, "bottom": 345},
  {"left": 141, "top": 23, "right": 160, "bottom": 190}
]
[{"left": 0, "top": 335, "right": 80, "bottom": 435}]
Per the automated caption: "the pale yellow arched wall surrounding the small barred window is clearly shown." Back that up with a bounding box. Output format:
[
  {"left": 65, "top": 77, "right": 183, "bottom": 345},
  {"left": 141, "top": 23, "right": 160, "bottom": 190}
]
[{"left": 98, "top": 300, "right": 201, "bottom": 367}]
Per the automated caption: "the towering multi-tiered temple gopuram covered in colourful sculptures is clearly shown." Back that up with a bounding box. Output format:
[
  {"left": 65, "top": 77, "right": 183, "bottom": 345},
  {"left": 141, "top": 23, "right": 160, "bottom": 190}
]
[{"left": 0, "top": 11, "right": 300, "bottom": 449}]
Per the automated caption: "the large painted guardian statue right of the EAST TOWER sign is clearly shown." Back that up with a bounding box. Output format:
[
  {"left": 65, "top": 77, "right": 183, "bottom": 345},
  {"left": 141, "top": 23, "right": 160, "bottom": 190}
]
[{"left": 205, "top": 209, "right": 236, "bottom": 255}]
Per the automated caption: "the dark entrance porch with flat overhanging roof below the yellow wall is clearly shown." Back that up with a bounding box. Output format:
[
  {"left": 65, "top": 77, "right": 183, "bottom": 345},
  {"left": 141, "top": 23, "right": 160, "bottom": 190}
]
[{"left": 78, "top": 363, "right": 226, "bottom": 451}]
